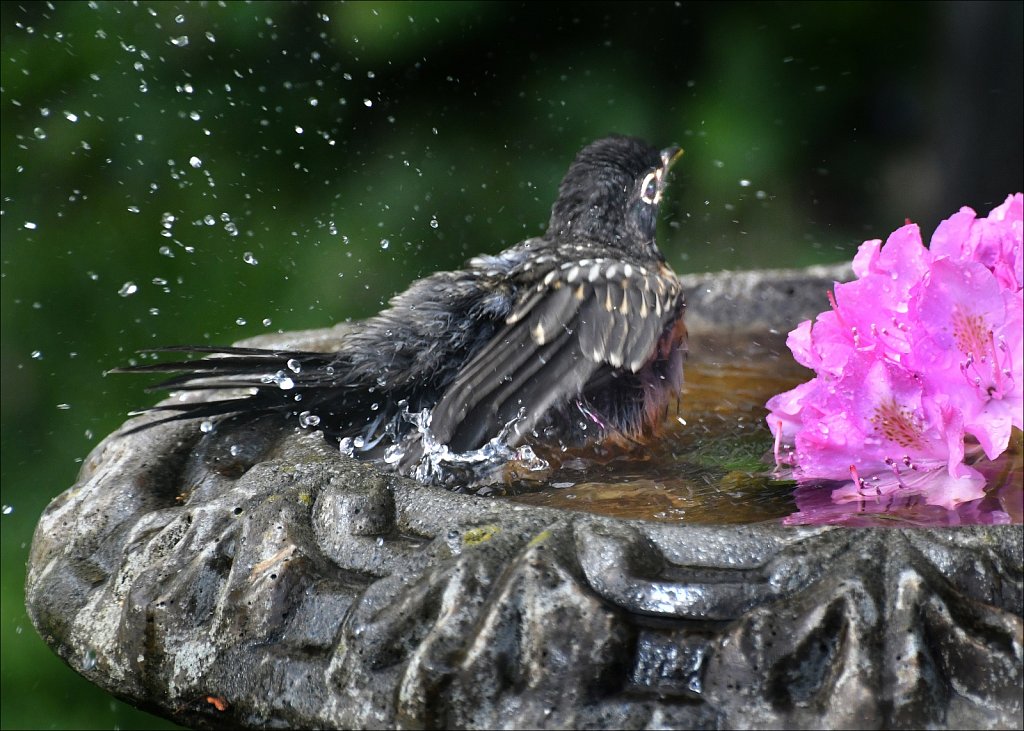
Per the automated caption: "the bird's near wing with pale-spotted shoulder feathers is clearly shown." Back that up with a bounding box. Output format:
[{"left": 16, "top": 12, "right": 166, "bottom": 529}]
[{"left": 430, "top": 258, "right": 681, "bottom": 452}]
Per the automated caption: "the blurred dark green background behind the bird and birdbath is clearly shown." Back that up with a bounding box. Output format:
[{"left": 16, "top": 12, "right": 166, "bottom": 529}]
[{"left": 0, "top": 2, "right": 1024, "bottom": 728}]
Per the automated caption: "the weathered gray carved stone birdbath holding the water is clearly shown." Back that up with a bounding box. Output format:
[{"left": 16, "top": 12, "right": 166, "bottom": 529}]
[{"left": 28, "top": 264, "right": 1024, "bottom": 728}]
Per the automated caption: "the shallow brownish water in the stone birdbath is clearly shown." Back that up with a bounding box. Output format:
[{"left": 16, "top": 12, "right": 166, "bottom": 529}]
[{"left": 506, "top": 336, "right": 1024, "bottom": 526}]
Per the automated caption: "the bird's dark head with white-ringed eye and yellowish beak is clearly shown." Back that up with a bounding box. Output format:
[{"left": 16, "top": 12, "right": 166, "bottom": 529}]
[{"left": 545, "top": 136, "right": 683, "bottom": 258}]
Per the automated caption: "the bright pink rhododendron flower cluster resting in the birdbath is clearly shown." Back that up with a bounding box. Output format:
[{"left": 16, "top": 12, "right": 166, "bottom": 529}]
[{"left": 767, "top": 194, "right": 1024, "bottom": 508}]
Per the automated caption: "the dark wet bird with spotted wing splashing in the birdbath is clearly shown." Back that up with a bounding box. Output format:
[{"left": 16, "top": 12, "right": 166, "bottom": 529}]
[{"left": 117, "top": 136, "right": 686, "bottom": 481}]
